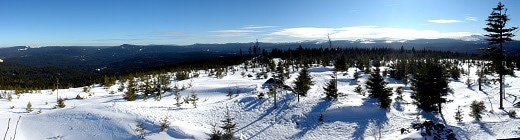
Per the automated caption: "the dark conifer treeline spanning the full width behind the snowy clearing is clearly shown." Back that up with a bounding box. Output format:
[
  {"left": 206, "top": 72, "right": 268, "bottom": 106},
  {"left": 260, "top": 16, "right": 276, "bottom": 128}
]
[{"left": 0, "top": 46, "right": 520, "bottom": 90}]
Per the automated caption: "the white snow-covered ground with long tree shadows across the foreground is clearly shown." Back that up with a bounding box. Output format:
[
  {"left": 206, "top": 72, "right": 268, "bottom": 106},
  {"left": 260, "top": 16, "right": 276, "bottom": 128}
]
[{"left": 0, "top": 62, "right": 520, "bottom": 140}]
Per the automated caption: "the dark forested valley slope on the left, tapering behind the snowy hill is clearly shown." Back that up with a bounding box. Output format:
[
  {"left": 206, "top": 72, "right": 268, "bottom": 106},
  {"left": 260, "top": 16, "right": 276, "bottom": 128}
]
[{"left": 0, "top": 55, "right": 250, "bottom": 91}]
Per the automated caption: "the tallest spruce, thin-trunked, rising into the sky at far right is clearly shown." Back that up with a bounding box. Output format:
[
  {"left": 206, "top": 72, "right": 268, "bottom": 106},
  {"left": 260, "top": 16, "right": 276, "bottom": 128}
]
[{"left": 484, "top": 2, "right": 518, "bottom": 109}]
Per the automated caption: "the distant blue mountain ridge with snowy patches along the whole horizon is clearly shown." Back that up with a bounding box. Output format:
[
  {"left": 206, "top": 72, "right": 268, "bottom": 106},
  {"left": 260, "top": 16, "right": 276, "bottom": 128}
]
[{"left": 0, "top": 35, "right": 520, "bottom": 73}]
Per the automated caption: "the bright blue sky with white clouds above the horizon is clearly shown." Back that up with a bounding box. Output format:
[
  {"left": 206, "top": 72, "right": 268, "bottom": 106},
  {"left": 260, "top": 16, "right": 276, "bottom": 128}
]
[{"left": 0, "top": 0, "right": 520, "bottom": 47}]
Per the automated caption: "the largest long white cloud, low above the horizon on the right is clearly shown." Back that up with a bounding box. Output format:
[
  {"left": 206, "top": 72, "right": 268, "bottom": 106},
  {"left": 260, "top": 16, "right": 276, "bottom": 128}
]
[{"left": 270, "top": 26, "right": 472, "bottom": 40}]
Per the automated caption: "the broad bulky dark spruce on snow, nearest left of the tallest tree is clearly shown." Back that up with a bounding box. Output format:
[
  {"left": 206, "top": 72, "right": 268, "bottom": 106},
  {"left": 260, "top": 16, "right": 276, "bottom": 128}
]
[{"left": 411, "top": 59, "right": 450, "bottom": 112}]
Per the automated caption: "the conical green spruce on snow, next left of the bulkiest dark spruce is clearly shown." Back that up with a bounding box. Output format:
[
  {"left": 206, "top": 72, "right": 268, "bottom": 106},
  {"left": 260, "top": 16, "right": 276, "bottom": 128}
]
[{"left": 366, "top": 68, "right": 392, "bottom": 109}]
